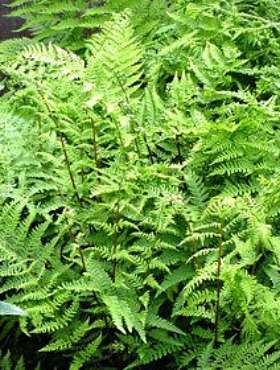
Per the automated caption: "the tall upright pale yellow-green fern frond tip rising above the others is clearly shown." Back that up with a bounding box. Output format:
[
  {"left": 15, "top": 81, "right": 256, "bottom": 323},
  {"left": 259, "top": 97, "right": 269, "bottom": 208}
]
[{"left": 86, "top": 13, "right": 142, "bottom": 104}]
